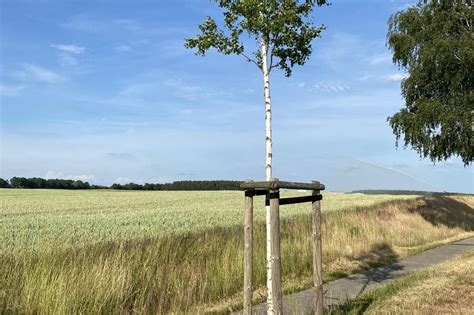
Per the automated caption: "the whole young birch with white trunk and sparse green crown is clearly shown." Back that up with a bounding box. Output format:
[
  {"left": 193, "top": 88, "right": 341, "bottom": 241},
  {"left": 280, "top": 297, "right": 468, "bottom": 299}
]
[{"left": 185, "top": 0, "right": 326, "bottom": 312}]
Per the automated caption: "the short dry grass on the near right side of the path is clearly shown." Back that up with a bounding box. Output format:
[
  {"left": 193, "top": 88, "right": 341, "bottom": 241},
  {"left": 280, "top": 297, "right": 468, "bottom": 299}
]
[{"left": 328, "top": 251, "right": 474, "bottom": 315}]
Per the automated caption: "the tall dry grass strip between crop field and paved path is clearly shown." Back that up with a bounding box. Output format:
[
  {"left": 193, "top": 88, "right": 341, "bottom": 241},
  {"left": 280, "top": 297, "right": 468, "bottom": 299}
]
[{"left": 0, "top": 197, "right": 474, "bottom": 313}]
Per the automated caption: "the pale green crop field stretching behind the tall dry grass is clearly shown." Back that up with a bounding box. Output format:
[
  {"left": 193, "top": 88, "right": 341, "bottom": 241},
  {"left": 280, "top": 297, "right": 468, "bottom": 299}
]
[{"left": 0, "top": 189, "right": 414, "bottom": 251}]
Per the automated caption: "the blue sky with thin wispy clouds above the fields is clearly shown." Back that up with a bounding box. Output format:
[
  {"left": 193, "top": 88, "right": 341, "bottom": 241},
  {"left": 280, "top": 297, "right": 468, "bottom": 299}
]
[{"left": 0, "top": 0, "right": 474, "bottom": 193}]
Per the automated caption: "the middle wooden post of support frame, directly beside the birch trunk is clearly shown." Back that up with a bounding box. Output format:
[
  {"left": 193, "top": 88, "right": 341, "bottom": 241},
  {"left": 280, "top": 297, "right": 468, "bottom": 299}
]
[{"left": 268, "top": 189, "right": 283, "bottom": 314}]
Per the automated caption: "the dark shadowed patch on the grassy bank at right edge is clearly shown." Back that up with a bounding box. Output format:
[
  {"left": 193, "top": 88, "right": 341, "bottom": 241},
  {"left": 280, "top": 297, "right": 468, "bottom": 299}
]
[{"left": 409, "top": 196, "right": 474, "bottom": 232}]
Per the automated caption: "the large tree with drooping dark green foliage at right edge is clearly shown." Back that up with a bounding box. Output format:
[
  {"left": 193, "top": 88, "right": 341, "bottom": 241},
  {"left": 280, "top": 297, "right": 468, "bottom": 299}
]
[{"left": 388, "top": 0, "right": 474, "bottom": 165}]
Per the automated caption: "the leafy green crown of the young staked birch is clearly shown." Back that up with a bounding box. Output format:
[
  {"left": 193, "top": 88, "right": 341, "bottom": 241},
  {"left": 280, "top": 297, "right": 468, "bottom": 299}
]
[{"left": 185, "top": 0, "right": 326, "bottom": 76}]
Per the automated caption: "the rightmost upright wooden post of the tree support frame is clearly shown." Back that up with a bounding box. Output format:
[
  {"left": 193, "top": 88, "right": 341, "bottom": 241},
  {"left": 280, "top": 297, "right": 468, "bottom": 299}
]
[{"left": 312, "top": 190, "right": 324, "bottom": 315}]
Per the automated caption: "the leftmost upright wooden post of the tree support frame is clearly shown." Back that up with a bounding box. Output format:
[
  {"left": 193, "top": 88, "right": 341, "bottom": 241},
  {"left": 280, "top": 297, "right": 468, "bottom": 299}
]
[{"left": 244, "top": 191, "right": 254, "bottom": 315}]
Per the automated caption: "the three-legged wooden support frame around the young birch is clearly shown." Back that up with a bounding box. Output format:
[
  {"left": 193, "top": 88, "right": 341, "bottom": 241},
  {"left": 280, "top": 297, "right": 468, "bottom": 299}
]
[{"left": 240, "top": 178, "right": 325, "bottom": 315}]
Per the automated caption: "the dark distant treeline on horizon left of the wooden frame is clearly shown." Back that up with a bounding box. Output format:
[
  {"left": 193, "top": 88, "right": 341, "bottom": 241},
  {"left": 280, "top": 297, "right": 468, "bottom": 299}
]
[{"left": 0, "top": 177, "right": 241, "bottom": 190}]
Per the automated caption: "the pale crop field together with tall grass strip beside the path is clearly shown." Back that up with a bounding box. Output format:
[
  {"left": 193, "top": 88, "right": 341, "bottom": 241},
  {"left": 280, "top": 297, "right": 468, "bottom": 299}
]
[{"left": 0, "top": 189, "right": 474, "bottom": 313}]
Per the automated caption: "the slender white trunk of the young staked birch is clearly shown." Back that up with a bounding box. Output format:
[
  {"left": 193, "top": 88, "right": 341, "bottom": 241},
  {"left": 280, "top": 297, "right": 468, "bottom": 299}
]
[{"left": 261, "top": 36, "right": 274, "bottom": 314}]
